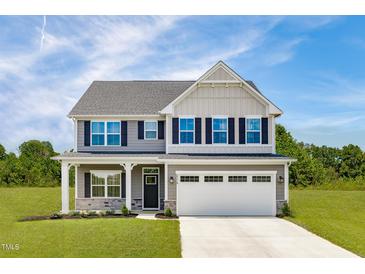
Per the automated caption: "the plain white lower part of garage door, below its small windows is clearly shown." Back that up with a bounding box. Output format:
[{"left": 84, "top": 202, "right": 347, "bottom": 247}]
[{"left": 177, "top": 173, "right": 275, "bottom": 216}]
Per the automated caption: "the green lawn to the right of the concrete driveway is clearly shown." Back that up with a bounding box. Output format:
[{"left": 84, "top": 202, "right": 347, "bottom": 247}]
[{"left": 287, "top": 190, "right": 365, "bottom": 257}]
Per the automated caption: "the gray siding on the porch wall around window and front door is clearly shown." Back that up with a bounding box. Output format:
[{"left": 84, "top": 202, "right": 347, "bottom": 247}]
[{"left": 77, "top": 165, "right": 165, "bottom": 209}]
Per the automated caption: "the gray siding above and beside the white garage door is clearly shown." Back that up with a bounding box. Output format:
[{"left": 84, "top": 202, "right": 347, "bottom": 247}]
[{"left": 168, "top": 165, "right": 285, "bottom": 200}]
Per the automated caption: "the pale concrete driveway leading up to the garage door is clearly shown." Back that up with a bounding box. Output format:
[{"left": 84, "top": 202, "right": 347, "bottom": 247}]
[{"left": 180, "top": 217, "right": 357, "bottom": 258}]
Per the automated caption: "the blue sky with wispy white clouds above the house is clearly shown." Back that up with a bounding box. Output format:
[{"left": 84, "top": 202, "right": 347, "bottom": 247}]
[{"left": 0, "top": 16, "right": 365, "bottom": 152}]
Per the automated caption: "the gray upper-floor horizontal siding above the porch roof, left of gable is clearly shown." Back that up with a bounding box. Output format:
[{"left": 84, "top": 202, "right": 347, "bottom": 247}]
[{"left": 77, "top": 120, "right": 166, "bottom": 152}]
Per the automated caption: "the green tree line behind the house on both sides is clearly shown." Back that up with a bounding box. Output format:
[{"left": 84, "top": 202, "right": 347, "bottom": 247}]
[{"left": 0, "top": 125, "right": 365, "bottom": 187}]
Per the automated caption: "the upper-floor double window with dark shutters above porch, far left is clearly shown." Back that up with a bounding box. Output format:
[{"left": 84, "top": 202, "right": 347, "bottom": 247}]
[{"left": 91, "top": 121, "right": 120, "bottom": 146}]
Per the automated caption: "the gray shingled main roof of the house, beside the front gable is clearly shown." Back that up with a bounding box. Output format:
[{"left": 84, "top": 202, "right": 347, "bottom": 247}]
[{"left": 69, "top": 78, "right": 261, "bottom": 116}]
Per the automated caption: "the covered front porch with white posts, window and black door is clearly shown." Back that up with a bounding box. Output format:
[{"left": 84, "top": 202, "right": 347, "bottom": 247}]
[{"left": 58, "top": 155, "right": 168, "bottom": 214}]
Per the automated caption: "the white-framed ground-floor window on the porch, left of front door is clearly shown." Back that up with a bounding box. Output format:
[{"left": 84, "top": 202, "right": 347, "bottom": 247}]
[{"left": 91, "top": 171, "right": 122, "bottom": 198}]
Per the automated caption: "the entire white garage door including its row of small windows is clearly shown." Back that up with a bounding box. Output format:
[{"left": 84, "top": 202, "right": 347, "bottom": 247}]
[{"left": 176, "top": 171, "right": 276, "bottom": 216}]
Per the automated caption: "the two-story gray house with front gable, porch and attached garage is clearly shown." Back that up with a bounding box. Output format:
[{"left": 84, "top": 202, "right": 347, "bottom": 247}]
[{"left": 55, "top": 61, "right": 293, "bottom": 215}]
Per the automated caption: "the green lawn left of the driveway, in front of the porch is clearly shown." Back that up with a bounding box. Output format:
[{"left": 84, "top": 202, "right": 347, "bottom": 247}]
[{"left": 0, "top": 188, "right": 181, "bottom": 258}]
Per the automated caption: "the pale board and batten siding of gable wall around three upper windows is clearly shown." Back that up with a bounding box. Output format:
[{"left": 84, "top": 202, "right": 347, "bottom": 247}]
[{"left": 167, "top": 84, "right": 274, "bottom": 153}]
